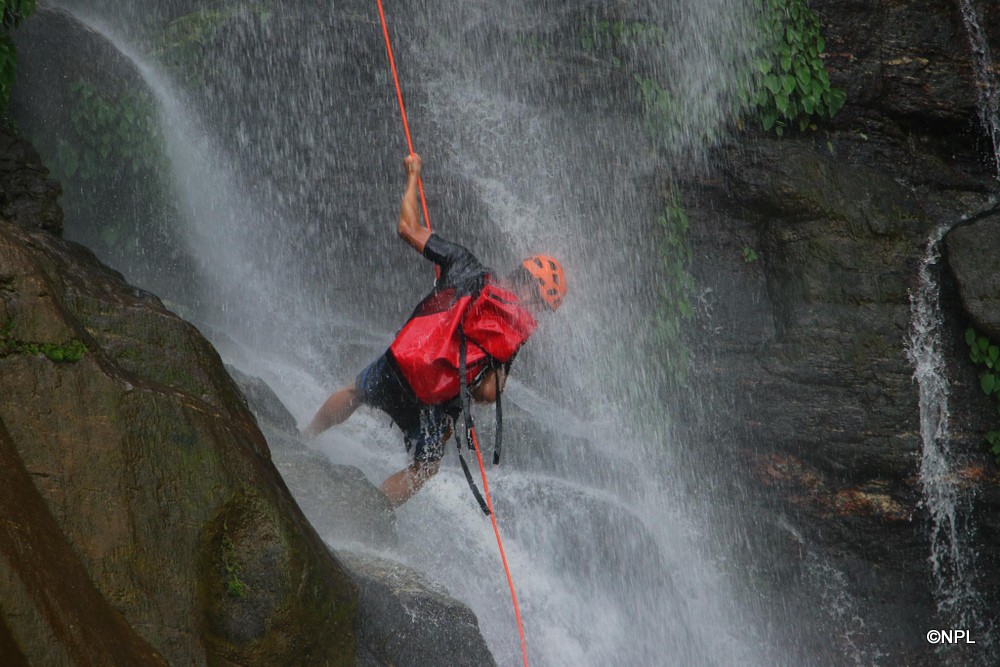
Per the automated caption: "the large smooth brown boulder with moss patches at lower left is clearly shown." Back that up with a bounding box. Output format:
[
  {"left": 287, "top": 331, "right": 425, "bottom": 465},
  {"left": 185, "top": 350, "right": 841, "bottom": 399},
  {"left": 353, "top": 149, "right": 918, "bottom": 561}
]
[{"left": 0, "top": 209, "right": 356, "bottom": 664}]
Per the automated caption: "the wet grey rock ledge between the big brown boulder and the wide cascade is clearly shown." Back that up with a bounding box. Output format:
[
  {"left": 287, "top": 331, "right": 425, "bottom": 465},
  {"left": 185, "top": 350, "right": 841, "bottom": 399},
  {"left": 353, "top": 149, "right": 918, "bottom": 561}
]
[{"left": 223, "top": 366, "right": 495, "bottom": 667}]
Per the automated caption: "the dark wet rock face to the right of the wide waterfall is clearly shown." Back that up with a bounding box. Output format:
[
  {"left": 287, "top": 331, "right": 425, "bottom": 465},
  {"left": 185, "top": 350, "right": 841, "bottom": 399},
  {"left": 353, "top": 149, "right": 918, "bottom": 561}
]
[{"left": 682, "top": 1, "right": 1000, "bottom": 664}]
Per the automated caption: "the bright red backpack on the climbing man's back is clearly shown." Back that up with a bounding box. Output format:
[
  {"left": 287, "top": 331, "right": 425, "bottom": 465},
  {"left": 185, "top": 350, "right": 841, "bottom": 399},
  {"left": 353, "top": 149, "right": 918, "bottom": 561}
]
[{"left": 389, "top": 278, "right": 537, "bottom": 405}]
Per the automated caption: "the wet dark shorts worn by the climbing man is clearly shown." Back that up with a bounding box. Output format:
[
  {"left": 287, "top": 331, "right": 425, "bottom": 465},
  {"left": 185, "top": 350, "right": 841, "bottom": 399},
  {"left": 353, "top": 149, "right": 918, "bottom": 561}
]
[{"left": 354, "top": 351, "right": 461, "bottom": 463}]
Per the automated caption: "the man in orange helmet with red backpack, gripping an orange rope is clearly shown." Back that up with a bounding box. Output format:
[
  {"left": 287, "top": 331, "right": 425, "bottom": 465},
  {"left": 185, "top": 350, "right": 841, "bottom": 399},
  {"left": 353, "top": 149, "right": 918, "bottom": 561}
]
[{"left": 302, "top": 153, "right": 566, "bottom": 507}]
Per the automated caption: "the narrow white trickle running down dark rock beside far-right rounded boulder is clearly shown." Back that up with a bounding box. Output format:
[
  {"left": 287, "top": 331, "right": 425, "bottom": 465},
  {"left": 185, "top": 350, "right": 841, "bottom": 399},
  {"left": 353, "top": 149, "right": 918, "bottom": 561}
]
[{"left": 907, "top": 226, "right": 982, "bottom": 630}]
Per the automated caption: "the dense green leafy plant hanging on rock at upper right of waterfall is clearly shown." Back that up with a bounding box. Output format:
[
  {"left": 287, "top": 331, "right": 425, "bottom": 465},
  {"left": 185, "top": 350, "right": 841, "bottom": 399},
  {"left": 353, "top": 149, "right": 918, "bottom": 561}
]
[{"left": 748, "top": 0, "right": 846, "bottom": 135}]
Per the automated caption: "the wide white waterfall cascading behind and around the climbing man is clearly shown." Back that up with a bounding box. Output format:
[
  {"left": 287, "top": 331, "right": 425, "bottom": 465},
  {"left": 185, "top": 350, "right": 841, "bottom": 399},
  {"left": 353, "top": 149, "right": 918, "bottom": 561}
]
[{"left": 15, "top": 0, "right": 844, "bottom": 665}]
